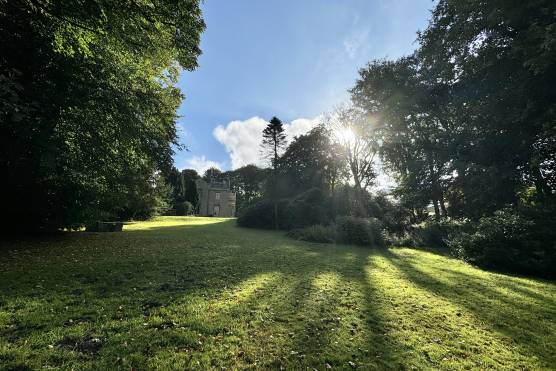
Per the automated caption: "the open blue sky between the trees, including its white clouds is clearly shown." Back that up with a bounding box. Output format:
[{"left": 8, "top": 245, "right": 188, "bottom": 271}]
[{"left": 174, "top": 0, "right": 433, "bottom": 171}]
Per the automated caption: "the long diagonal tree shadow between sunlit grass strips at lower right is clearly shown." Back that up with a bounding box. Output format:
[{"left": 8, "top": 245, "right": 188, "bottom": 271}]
[{"left": 387, "top": 253, "right": 556, "bottom": 367}]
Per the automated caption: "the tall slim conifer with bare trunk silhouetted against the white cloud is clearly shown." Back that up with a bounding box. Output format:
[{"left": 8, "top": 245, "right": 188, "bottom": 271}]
[{"left": 262, "top": 117, "right": 287, "bottom": 229}]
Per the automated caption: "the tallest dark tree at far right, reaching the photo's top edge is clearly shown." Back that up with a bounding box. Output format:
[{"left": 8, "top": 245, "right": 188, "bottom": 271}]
[{"left": 417, "top": 0, "right": 556, "bottom": 218}]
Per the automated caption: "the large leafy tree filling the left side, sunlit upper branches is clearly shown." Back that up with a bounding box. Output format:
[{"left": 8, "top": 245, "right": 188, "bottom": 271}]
[{"left": 0, "top": 0, "right": 204, "bottom": 228}]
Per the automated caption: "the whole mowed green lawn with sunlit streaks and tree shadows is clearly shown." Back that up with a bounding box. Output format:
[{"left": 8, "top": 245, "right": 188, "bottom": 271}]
[{"left": 0, "top": 217, "right": 556, "bottom": 370}]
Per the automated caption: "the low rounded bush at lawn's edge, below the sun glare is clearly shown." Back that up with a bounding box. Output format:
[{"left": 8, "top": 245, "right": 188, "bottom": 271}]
[{"left": 336, "top": 216, "right": 385, "bottom": 247}]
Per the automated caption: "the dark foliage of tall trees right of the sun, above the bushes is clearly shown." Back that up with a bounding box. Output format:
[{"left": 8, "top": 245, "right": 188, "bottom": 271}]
[{"left": 352, "top": 0, "right": 556, "bottom": 221}]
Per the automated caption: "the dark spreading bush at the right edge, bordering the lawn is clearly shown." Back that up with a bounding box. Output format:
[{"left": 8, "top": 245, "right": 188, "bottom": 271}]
[{"left": 449, "top": 207, "right": 556, "bottom": 276}]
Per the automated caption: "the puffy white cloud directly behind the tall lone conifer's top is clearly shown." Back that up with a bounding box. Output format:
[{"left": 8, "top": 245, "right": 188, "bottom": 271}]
[{"left": 213, "top": 116, "right": 319, "bottom": 169}]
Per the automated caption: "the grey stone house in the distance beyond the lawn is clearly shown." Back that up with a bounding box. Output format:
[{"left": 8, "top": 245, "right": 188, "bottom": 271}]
[{"left": 196, "top": 179, "right": 236, "bottom": 218}]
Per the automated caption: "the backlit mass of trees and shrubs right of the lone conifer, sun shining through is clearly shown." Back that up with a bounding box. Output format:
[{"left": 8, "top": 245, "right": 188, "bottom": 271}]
[{"left": 239, "top": 0, "right": 556, "bottom": 276}]
